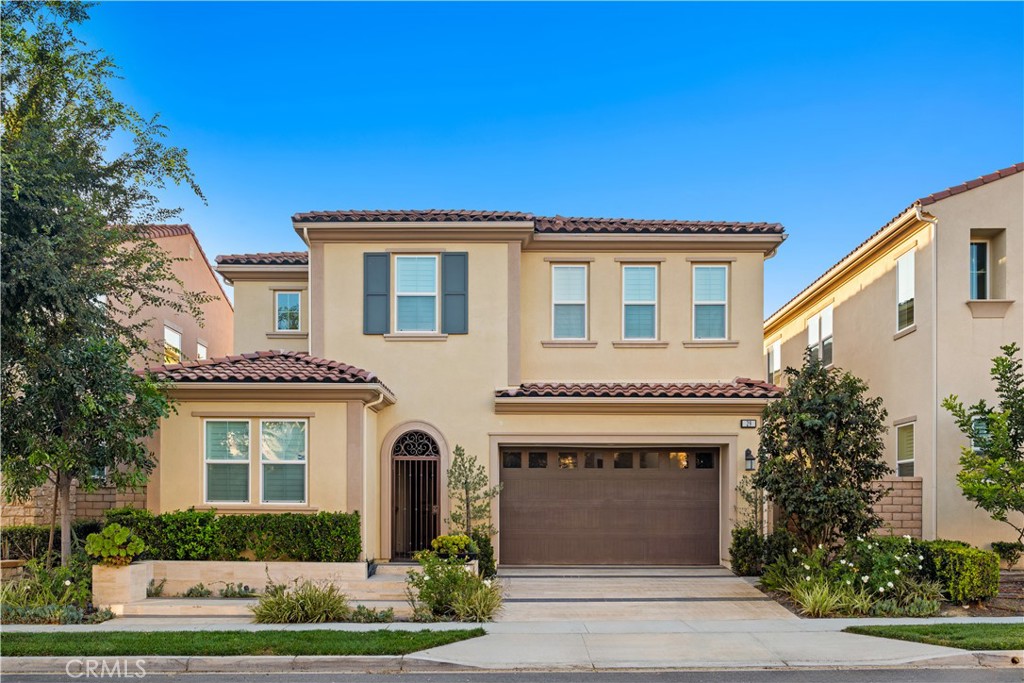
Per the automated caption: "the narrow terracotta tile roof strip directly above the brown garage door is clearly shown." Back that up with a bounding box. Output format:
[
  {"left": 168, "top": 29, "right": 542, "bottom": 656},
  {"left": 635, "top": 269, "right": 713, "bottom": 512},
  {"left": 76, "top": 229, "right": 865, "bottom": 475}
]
[{"left": 495, "top": 377, "right": 781, "bottom": 398}]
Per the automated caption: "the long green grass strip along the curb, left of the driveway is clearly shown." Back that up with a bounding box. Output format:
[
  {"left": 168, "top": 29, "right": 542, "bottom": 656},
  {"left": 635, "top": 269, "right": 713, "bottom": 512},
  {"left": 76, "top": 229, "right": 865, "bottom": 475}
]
[{"left": 0, "top": 629, "right": 484, "bottom": 656}]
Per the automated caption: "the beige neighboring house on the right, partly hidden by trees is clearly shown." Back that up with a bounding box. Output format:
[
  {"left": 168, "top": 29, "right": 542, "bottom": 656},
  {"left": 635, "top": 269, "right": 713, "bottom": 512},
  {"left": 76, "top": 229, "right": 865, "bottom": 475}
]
[{"left": 764, "top": 164, "right": 1024, "bottom": 545}]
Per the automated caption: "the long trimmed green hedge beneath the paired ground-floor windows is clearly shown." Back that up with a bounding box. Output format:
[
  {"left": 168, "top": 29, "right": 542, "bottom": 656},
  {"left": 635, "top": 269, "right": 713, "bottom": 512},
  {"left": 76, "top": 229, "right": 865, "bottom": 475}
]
[{"left": 106, "top": 508, "right": 362, "bottom": 562}]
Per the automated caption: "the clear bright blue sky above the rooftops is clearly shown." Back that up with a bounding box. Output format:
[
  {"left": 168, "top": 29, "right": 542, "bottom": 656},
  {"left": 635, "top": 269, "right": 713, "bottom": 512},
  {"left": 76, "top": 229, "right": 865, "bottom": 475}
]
[{"left": 81, "top": 2, "right": 1024, "bottom": 312}]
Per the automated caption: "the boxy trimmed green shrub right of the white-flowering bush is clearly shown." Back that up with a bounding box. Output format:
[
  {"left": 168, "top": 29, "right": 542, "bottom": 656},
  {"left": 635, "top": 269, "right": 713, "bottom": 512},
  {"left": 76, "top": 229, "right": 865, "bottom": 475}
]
[{"left": 926, "top": 541, "right": 999, "bottom": 604}]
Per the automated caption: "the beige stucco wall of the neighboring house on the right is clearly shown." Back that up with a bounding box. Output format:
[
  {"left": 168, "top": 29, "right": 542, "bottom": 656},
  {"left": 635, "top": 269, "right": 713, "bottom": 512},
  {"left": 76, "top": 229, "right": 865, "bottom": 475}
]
[{"left": 762, "top": 174, "right": 1024, "bottom": 546}]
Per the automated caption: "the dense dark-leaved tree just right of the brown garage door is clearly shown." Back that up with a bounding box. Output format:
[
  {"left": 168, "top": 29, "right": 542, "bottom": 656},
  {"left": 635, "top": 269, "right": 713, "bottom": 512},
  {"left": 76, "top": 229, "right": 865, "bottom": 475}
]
[{"left": 753, "top": 353, "right": 892, "bottom": 551}]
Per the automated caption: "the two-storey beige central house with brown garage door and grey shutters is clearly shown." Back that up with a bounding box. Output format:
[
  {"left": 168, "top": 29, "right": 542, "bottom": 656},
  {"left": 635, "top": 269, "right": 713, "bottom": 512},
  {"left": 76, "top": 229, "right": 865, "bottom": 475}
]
[{"left": 148, "top": 211, "right": 784, "bottom": 564}]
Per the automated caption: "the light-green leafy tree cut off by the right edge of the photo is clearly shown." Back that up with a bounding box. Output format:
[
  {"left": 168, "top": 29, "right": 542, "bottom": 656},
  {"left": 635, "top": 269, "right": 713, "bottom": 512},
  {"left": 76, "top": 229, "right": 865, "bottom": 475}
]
[{"left": 942, "top": 343, "right": 1024, "bottom": 543}]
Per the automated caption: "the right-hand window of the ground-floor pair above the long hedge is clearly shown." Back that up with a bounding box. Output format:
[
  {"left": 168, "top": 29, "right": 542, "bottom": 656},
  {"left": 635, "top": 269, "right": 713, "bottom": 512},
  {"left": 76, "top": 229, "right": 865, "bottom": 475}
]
[{"left": 259, "top": 420, "right": 307, "bottom": 503}]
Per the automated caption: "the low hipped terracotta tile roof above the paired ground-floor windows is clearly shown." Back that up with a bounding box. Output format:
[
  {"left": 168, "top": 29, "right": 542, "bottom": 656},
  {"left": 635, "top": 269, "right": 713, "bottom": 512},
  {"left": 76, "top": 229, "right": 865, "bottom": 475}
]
[{"left": 138, "top": 351, "right": 381, "bottom": 384}]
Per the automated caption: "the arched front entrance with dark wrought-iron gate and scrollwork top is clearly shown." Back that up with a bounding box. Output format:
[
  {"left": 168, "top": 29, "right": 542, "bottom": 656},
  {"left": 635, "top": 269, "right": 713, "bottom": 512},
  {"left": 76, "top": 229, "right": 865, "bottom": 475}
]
[{"left": 391, "top": 430, "right": 440, "bottom": 559}]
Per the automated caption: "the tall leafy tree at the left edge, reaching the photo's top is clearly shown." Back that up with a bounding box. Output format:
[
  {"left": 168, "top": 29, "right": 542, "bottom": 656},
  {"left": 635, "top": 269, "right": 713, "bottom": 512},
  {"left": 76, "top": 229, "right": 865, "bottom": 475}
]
[{"left": 0, "top": 1, "right": 207, "bottom": 562}]
